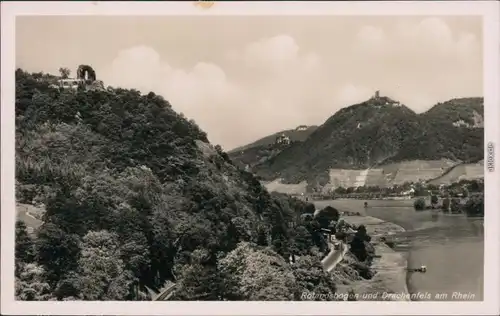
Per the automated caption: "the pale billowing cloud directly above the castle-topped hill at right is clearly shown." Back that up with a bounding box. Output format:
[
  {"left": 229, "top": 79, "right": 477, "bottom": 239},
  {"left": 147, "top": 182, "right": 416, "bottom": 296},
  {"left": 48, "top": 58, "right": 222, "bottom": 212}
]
[{"left": 351, "top": 17, "right": 482, "bottom": 112}]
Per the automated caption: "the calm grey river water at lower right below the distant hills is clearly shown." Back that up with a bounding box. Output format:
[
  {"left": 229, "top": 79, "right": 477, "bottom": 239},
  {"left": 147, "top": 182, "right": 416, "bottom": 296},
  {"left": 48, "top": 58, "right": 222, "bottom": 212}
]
[{"left": 318, "top": 201, "right": 484, "bottom": 301}]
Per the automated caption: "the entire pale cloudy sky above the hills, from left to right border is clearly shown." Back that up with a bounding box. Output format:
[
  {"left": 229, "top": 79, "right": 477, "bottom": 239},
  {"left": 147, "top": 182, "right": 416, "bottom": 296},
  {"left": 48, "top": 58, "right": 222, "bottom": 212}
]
[{"left": 16, "top": 16, "right": 483, "bottom": 150}]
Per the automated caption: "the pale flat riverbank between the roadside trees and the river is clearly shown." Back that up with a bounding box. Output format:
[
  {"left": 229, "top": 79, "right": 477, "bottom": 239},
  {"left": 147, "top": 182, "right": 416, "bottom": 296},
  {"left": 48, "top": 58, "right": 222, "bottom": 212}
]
[{"left": 334, "top": 216, "right": 410, "bottom": 301}]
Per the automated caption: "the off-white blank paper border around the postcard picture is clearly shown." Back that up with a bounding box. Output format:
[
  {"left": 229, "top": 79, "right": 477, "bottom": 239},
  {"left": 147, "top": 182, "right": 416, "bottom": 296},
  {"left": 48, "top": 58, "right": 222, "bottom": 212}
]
[{"left": 1, "top": 1, "right": 500, "bottom": 315}]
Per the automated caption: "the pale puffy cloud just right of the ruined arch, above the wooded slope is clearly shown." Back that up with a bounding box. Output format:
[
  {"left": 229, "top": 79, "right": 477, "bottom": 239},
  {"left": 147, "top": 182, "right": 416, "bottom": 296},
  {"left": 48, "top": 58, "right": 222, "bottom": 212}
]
[{"left": 103, "top": 46, "right": 245, "bottom": 148}]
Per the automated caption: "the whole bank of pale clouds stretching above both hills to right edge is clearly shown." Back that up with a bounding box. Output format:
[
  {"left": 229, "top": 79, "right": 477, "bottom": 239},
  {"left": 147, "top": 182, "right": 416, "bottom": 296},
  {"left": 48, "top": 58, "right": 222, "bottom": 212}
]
[{"left": 103, "top": 18, "right": 482, "bottom": 149}]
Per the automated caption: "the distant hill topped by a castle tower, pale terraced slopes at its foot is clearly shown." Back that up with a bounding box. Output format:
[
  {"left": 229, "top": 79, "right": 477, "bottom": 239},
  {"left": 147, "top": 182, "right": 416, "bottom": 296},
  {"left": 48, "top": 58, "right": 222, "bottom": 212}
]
[{"left": 232, "top": 96, "right": 484, "bottom": 193}]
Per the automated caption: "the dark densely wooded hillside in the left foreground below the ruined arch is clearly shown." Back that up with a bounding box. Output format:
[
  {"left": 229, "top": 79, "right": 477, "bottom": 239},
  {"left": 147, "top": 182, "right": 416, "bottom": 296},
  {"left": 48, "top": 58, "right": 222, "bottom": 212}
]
[{"left": 15, "top": 69, "right": 335, "bottom": 300}]
